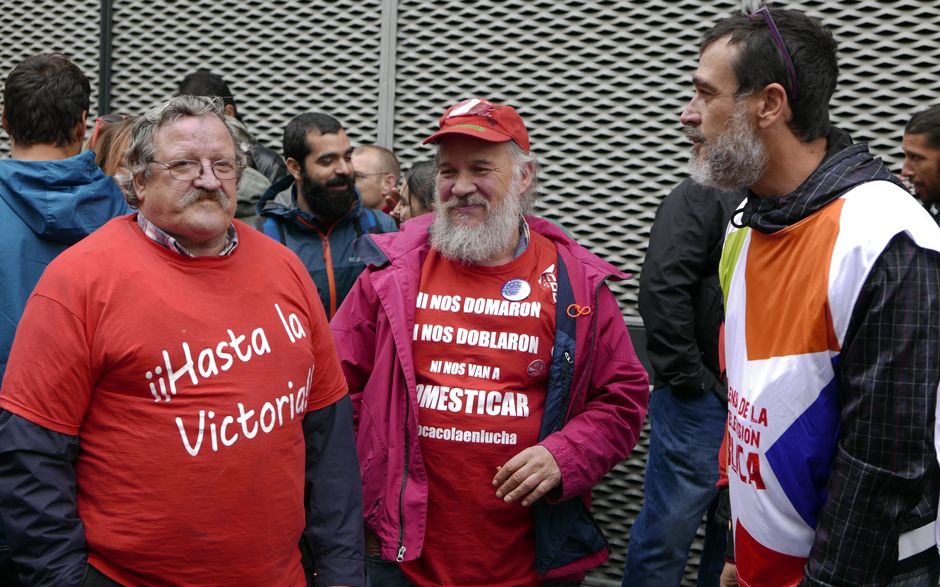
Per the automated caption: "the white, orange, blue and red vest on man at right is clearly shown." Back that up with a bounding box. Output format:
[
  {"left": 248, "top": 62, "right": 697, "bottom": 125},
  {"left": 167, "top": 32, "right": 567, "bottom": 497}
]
[{"left": 719, "top": 181, "right": 940, "bottom": 587}]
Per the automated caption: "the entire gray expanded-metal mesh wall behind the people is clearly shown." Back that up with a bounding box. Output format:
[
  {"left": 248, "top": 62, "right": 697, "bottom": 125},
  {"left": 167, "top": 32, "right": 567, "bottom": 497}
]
[{"left": 0, "top": 0, "right": 940, "bottom": 579}]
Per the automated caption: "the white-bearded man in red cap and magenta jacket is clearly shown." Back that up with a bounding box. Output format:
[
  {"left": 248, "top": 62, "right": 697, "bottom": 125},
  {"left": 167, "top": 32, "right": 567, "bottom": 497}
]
[{"left": 331, "top": 99, "right": 648, "bottom": 586}]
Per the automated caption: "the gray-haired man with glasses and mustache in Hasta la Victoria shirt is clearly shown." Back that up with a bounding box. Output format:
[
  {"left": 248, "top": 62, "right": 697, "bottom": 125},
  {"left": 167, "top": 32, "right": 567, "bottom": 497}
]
[{"left": 0, "top": 96, "right": 363, "bottom": 587}]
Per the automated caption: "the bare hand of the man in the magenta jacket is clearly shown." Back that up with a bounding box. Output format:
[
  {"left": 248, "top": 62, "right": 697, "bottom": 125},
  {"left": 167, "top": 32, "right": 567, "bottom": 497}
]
[{"left": 493, "top": 444, "right": 561, "bottom": 507}]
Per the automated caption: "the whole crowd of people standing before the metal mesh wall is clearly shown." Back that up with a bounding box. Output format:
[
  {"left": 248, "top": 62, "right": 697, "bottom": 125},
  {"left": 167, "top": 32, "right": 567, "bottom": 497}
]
[{"left": 0, "top": 2, "right": 940, "bottom": 587}]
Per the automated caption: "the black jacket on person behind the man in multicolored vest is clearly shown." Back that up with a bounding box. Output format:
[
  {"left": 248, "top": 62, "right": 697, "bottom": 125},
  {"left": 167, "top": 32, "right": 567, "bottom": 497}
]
[{"left": 639, "top": 179, "right": 744, "bottom": 400}]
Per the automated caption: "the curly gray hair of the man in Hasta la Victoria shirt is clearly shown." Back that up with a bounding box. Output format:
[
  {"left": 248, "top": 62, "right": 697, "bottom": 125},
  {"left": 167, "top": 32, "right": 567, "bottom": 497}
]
[{"left": 119, "top": 96, "right": 248, "bottom": 208}]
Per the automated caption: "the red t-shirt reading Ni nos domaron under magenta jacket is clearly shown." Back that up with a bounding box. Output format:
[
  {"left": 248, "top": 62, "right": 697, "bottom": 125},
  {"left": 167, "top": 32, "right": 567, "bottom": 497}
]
[{"left": 402, "top": 234, "right": 557, "bottom": 587}]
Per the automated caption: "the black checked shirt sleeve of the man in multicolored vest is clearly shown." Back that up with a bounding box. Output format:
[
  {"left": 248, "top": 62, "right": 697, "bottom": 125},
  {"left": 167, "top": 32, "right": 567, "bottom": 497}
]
[{"left": 803, "top": 235, "right": 940, "bottom": 585}]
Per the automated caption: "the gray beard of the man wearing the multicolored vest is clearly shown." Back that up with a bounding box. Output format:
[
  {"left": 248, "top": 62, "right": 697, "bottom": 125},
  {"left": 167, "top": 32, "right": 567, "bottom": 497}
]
[{"left": 689, "top": 107, "right": 767, "bottom": 190}]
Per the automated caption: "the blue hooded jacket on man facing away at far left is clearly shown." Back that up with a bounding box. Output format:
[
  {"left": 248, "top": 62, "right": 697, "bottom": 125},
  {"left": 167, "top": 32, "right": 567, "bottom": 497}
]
[{"left": 0, "top": 151, "right": 127, "bottom": 379}]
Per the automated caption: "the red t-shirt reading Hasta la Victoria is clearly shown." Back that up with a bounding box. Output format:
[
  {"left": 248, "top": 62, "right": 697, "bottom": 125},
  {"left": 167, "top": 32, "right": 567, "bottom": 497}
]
[{"left": 0, "top": 216, "right": 346, "bottom": 585}]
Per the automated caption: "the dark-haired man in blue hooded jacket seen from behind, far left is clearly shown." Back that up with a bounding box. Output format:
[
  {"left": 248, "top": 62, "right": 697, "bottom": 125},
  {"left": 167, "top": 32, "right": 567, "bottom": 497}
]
[{"left": 0, "top": 53, "right": 127, "bottom": 584}]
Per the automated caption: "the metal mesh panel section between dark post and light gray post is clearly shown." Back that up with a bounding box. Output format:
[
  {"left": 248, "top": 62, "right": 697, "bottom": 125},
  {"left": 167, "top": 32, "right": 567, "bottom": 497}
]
[{"left": 112, "top": 0, "right": 382, "bottom": 152}]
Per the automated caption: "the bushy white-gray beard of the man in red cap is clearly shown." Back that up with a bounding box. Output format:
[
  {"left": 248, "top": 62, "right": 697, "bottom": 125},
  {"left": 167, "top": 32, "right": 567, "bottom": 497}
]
[{"left": 429, "top": 177, "right": 524, "bottom": 265}]
